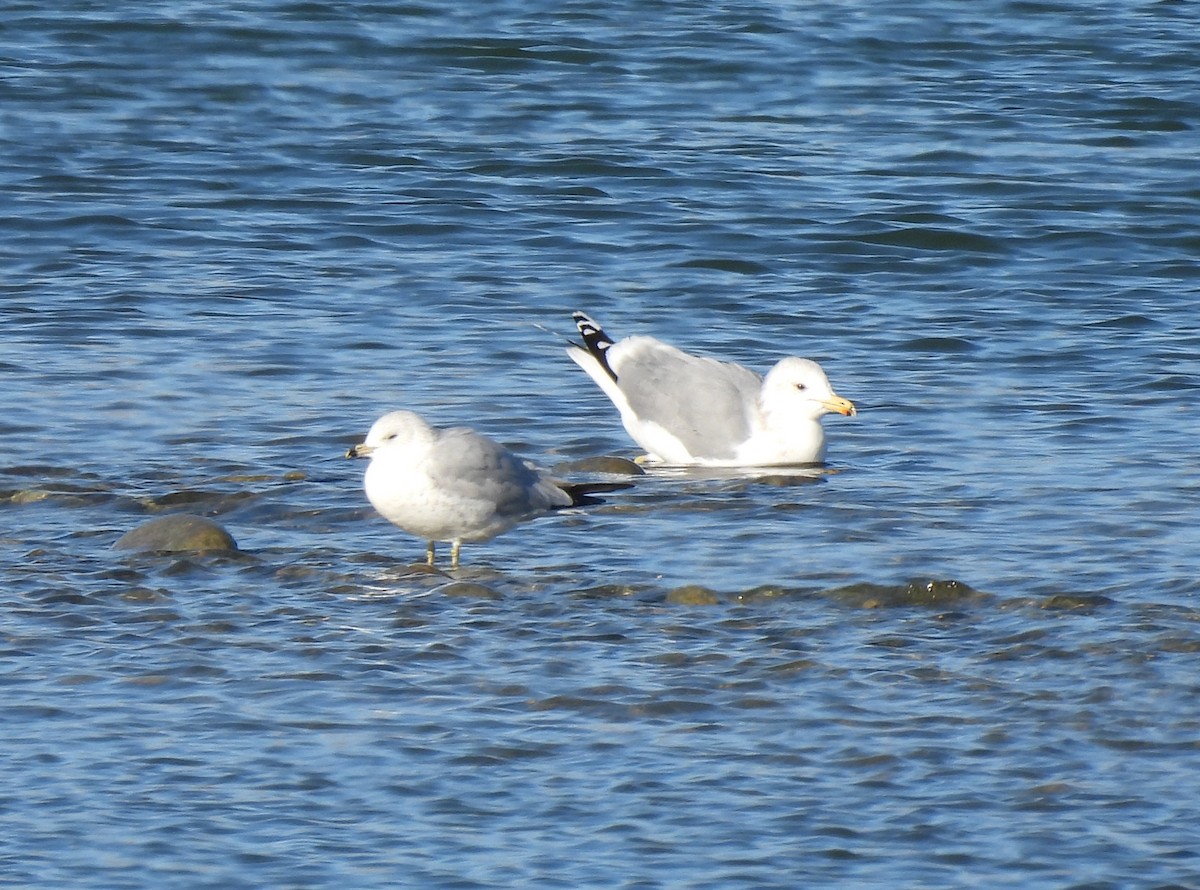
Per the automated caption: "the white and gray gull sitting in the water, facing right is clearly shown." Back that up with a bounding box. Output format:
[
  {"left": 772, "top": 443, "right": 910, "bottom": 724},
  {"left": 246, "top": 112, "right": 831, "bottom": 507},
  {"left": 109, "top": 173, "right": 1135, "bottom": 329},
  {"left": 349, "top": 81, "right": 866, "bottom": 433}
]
[{"left": 566, "top": 312, "right": 857, "bottom": 467}]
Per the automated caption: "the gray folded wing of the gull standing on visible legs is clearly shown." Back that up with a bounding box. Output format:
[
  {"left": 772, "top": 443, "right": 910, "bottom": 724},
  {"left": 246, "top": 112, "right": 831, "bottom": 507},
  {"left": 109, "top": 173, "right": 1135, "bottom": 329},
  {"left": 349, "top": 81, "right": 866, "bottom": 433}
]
[{"left": 430, "top": 427, "right": 571, "bottom": 518}]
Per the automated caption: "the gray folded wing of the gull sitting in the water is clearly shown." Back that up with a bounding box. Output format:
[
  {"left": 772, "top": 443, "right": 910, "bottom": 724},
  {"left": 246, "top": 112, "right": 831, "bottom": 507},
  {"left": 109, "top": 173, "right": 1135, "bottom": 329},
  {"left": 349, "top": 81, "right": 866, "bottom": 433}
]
[{"left": 608, "top": 337, "right": 762, "bottom": 458}]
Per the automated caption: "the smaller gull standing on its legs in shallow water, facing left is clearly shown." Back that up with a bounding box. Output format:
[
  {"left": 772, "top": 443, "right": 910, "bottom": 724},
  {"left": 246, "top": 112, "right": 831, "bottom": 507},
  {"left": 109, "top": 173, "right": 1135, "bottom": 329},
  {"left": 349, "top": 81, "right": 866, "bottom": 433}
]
[{"left": 346, "top": 411, "right": 628, "bottom": 567}]
